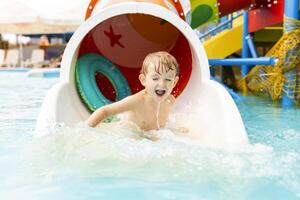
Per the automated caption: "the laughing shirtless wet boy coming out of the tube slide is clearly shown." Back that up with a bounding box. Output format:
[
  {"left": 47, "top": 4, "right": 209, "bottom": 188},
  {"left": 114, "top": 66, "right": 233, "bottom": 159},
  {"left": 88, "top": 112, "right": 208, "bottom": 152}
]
[{"left": 87, "top": 52, "right": 178, "bottom": 131}]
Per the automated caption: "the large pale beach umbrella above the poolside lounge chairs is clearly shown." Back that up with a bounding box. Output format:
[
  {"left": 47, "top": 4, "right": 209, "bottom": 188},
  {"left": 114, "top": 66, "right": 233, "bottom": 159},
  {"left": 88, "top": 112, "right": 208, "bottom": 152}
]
[{"left": 0, "top": 0, "right": 89, "bottom": 66}]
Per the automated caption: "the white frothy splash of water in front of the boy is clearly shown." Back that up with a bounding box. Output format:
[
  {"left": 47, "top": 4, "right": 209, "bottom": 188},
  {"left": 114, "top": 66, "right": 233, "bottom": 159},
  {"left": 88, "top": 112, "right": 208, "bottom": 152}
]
[{"left": 22, "top": 123, "right": 273, "bottom": 182}]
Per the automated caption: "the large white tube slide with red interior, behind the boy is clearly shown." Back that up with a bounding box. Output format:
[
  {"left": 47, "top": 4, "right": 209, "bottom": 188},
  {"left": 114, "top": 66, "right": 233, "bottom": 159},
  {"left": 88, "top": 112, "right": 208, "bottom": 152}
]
[{"left": 36, "top": 0, "right": 251, "bottom": 146}]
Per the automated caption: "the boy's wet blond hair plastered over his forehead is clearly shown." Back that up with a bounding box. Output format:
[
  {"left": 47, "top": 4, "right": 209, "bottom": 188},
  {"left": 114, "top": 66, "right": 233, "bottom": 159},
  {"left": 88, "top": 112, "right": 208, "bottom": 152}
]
[{"left": 140, "top": 51, "right": 178, "bottom": 75}]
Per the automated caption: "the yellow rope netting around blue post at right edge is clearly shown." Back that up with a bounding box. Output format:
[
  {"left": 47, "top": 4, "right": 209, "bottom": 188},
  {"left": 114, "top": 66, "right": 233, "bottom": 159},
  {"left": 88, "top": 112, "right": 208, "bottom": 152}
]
[{"left": 237, "top": 16, "right": 300, "bottom": 102}]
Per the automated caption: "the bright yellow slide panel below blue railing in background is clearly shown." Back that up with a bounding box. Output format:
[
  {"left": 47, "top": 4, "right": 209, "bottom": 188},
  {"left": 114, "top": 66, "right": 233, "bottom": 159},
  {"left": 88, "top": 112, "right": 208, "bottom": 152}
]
[{"left": 203, "top": 16, "right": 243, "bottom": 58}]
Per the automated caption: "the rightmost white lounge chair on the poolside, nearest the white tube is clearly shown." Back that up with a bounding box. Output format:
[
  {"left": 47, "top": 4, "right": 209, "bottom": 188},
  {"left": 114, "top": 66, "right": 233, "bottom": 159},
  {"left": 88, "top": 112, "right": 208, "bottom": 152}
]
[{"left": 24, "top": 49, "right": 50, "bottom": 68}]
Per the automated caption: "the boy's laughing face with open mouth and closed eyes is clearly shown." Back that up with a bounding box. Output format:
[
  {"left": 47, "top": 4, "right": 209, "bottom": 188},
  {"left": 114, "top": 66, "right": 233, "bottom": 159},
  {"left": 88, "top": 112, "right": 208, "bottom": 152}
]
[{"left": 139, "top": 65, "right": 178, "bottom": 101}]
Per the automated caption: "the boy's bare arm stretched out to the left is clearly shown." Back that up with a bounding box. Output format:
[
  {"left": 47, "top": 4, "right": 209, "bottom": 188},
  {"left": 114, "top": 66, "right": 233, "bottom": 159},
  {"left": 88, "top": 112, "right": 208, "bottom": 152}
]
[{"left": 86, "top": 95, "right": 138, "bottom": 127}]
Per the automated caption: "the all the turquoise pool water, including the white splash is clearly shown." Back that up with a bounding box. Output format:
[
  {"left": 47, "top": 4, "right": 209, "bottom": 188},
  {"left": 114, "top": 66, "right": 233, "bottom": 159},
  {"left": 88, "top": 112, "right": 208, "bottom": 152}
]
[{"left": 0, "top": 73, "right": 300, "bottom": 200}]
